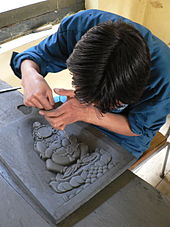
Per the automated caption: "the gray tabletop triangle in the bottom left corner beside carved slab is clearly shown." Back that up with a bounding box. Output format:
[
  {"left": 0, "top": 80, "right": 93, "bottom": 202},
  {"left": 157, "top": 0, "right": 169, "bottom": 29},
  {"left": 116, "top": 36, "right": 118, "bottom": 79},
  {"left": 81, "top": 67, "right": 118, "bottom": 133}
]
[{"left": 0, "top": 175, "right": 50, "bottom": 227}]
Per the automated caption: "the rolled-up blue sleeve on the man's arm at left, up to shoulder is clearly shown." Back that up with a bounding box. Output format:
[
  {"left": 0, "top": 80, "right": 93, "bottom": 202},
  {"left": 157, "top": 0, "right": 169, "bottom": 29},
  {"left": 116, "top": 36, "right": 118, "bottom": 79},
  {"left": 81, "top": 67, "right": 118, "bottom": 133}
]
[{"left": 11, "top": 13, "right": 85, "bottom": 78}]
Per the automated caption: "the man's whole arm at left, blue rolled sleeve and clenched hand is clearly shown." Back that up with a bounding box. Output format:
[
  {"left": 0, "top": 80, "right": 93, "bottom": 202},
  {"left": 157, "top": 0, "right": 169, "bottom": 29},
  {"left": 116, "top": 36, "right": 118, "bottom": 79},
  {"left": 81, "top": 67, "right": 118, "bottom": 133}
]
[{"left": 11, "top": 13, "right": 84, "bottom": 110}]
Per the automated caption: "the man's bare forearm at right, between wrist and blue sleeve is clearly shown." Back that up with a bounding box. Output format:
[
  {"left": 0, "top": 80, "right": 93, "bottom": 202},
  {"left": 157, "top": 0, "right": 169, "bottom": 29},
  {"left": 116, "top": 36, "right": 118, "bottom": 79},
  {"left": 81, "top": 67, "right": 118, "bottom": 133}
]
[{"left": 87, "top": 108, "right": 138, "bottom": 136}]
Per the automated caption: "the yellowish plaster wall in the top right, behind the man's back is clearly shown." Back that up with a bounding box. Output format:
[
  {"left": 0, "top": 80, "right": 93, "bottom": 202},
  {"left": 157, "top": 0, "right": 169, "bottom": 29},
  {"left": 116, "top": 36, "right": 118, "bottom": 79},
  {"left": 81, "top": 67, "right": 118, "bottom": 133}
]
[{"left": 86, "top": 0, "right": 170, "bottom": 45}]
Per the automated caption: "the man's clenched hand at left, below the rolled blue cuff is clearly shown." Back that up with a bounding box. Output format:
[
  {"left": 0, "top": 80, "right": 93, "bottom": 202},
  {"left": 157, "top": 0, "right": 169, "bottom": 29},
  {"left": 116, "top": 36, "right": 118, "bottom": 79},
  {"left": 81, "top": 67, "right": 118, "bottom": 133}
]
[{"left": 22, "top": 59, "right": 54, "bottom": 110}]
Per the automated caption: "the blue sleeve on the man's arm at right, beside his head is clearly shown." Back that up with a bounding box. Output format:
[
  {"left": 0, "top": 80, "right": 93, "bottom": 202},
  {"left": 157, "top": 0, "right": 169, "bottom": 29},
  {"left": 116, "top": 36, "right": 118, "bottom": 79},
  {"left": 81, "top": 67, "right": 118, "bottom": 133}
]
[{"left": 128, "top": 36, "right": 170, "bottom": 136}]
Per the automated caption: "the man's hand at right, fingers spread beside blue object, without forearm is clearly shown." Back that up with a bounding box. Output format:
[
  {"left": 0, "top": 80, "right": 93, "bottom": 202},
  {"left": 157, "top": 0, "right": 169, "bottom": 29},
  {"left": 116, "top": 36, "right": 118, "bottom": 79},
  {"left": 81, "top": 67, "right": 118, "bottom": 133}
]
[{"left": 39, "top": 89, "right": 96, "bottom": 130}]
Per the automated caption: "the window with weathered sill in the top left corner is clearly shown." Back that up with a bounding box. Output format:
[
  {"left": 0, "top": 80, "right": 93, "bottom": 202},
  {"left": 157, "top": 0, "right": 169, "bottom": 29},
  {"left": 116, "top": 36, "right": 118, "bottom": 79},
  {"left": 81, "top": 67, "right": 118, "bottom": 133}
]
[{"left": 0, "top": 0, "right": 85, "bottom": 44}]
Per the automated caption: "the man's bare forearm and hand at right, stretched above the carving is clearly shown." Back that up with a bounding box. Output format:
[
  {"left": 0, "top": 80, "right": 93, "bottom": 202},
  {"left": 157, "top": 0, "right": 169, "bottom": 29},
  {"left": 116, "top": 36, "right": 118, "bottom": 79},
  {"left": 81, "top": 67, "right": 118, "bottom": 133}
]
[{"left": 40, "top": 89, "right": 137, "bottom": 136}]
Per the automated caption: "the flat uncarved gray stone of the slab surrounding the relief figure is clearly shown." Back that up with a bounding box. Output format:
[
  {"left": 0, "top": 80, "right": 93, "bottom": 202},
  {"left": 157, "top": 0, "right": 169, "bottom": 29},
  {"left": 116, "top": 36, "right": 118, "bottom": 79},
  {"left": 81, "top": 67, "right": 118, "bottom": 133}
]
[{"left": 0, "top": 113, "right": 135, "bottom": 223}]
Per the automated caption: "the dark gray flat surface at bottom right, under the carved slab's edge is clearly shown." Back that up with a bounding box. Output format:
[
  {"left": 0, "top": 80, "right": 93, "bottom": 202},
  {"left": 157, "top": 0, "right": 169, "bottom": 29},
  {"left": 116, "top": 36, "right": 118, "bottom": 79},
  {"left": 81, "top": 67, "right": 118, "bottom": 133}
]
[{"left": 58, "top": 170, "right": 170, "bottom": 227}]
